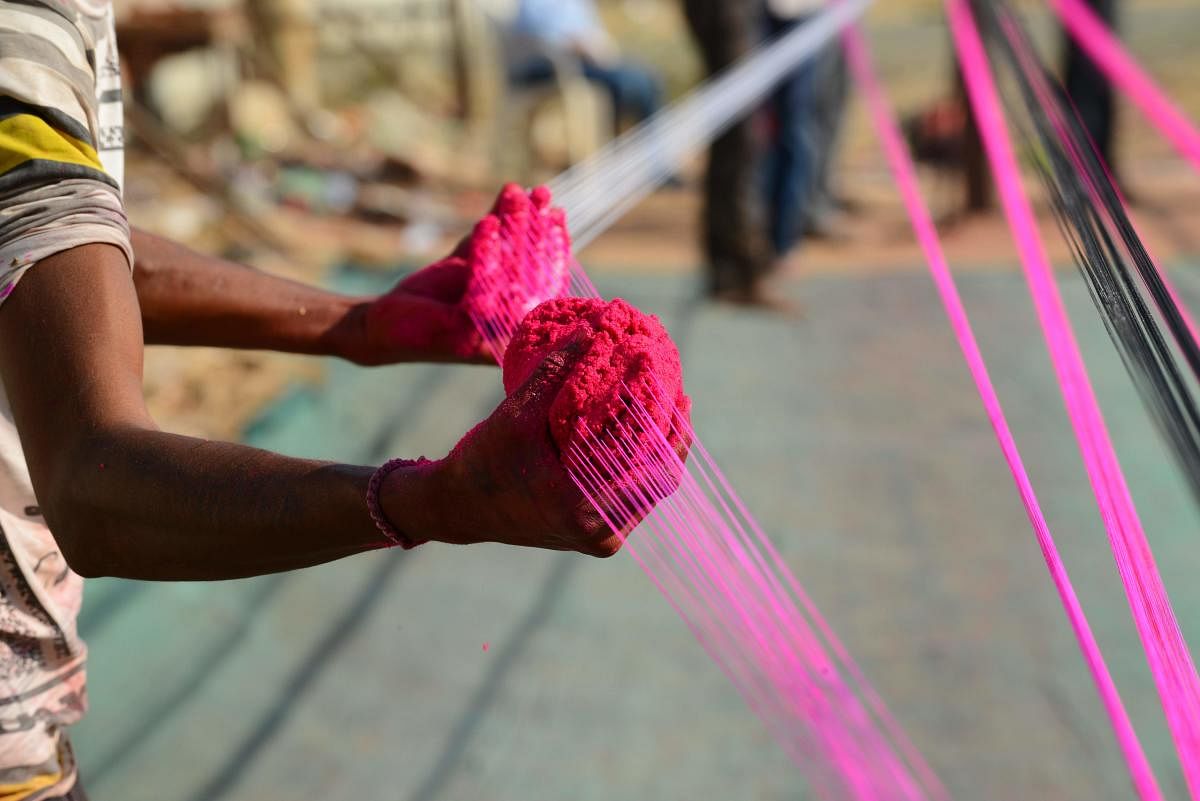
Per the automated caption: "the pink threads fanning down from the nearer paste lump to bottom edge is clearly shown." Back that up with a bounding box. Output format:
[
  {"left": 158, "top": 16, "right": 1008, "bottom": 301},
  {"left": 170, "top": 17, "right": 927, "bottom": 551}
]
[{"left": 568, "top": 395, "right": 926, "bottom": 799}]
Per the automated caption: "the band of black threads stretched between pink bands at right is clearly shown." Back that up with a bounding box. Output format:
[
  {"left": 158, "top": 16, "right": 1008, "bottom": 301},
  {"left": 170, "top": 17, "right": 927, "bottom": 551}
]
[{"left": 973, "top": 0, "right": 1200, "bottom": 502}]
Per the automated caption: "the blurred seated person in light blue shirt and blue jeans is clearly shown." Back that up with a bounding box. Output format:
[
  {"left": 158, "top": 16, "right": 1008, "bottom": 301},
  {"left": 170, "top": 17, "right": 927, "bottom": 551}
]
[{"left": 509, "top": 0, "right": 662, "bottom": 133}]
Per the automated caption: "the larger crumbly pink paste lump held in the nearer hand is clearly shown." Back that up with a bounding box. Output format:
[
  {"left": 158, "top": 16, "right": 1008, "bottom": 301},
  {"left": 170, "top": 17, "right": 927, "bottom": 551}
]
[{"left": 504, "top": 297, "right": 691, "bottom": 489}]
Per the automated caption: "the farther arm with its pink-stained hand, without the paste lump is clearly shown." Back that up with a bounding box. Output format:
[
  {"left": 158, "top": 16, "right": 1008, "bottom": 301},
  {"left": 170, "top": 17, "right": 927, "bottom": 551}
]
[{"left": 132, "top": 229, "right": 496, "bottom": 365}]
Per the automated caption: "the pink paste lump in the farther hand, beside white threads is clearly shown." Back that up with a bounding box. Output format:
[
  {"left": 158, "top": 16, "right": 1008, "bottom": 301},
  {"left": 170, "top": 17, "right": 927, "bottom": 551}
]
[{"left": 462, "top": 183, "right": 571, "bottom": 343}]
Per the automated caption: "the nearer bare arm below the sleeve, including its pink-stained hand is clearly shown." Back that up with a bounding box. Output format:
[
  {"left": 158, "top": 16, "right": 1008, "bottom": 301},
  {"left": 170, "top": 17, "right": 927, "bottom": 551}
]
[{"left": 0, "top": 245, "right": 619, "bottom": 580}]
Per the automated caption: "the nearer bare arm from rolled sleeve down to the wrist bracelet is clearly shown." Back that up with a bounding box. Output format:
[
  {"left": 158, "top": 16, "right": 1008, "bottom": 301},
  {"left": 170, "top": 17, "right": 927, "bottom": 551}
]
[{"left": 0, "top": 245, "right": 466, "bottom": 579}]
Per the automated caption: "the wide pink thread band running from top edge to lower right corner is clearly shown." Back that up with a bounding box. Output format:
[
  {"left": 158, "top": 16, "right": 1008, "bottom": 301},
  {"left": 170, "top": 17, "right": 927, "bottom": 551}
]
[{"left": 947, "top": 0, "right": 1200, "bottom": 797}]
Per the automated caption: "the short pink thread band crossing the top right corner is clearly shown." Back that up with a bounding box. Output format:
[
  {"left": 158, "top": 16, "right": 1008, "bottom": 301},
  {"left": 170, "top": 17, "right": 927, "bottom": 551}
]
[{"left": 1050, "top": 0, "right": 1200, "bottom": 169}]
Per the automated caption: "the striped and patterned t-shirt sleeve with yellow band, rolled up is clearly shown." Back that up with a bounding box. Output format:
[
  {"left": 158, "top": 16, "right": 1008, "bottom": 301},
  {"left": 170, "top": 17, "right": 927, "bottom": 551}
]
[{"left": 0, "top": 0, "right": 133, "bottom": 302}]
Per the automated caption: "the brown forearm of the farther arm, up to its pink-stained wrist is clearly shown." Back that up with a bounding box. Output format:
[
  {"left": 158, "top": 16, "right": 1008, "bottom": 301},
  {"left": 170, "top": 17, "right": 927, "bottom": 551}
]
[{"left": 133, "top": 229, "right": 364, "bottom": 357}]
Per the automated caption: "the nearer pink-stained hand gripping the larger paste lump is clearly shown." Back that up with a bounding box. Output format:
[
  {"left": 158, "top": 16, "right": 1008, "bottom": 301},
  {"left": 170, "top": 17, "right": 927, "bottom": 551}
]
[{"left": 380, "top": 342, "right": 641, "bottom": 556}]
